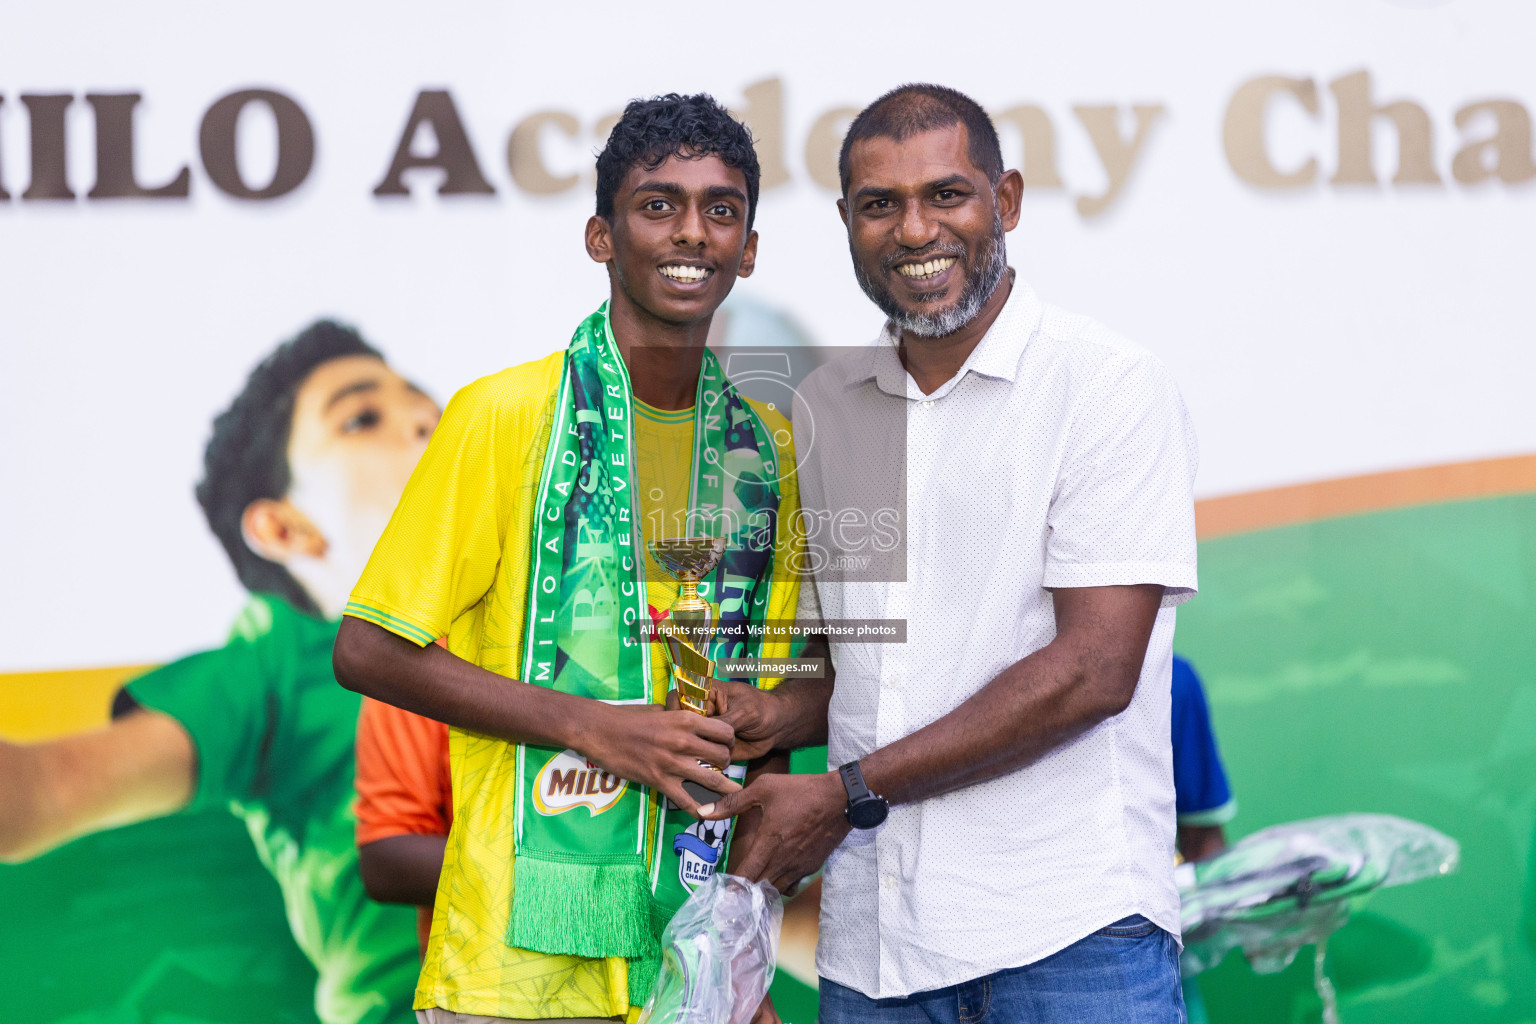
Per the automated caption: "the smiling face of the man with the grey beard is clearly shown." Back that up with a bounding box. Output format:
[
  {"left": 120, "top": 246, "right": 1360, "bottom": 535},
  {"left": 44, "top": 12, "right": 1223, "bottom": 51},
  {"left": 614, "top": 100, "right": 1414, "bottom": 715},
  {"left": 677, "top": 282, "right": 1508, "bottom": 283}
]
[{"left": 837, "top": 124, "right": 1018, "bottom": 338}]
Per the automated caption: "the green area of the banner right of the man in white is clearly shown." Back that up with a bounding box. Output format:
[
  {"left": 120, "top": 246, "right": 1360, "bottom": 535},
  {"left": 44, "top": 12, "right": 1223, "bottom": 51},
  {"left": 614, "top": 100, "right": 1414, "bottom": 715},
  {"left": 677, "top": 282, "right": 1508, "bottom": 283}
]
[{"left": 1177, "top": 494, "right": 1536, "bottom": 1022}]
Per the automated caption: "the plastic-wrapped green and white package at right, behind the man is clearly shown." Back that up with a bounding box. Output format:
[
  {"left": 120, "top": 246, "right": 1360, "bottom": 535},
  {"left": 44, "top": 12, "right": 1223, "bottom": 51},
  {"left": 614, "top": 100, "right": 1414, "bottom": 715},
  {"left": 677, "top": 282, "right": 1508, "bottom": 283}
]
[{"left": 1178, "top": 814, "right": 1461, "bottom": 1021}]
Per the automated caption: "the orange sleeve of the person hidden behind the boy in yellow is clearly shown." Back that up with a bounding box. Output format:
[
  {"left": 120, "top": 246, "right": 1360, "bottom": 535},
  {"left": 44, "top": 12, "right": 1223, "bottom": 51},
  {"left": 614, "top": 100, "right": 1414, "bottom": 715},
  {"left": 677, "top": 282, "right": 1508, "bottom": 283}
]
[{"left": 356, "top": 697, "right": 452, "bottom": 846}]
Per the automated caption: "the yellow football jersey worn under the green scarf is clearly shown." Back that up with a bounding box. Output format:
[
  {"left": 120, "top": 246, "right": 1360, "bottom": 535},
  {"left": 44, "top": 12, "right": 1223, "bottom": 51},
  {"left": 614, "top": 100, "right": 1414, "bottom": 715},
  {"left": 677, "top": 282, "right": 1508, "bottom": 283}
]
[{"left": 346, "top": 352, "right": 799, "bottom": 1018}]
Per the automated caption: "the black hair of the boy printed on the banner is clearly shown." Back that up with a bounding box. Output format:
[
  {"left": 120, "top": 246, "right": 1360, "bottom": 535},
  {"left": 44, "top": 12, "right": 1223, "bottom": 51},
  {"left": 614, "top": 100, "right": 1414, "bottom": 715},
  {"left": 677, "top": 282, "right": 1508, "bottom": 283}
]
[{"left": 197, "top": 319, "right": 384, "bottom": 616}]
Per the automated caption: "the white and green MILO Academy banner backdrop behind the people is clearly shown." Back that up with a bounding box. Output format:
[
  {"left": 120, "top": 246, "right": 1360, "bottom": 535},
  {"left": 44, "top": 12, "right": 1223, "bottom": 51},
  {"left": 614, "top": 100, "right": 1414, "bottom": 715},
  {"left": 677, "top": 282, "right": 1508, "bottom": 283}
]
[{"left": 0, "top": 0, "right": 1536, "bottom": 1024}]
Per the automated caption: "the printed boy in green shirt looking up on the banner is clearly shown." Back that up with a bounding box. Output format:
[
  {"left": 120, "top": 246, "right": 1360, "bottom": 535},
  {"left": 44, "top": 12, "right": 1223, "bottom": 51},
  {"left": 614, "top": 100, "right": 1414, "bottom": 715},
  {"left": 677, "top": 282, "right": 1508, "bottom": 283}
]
[{"left": 0, "top": 321, "right": 439, "bottom": 1024}]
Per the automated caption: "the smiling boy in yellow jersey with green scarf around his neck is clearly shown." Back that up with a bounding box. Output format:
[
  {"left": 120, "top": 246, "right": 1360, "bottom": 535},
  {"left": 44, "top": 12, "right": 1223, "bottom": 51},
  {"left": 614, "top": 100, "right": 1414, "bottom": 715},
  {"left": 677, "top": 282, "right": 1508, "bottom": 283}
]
[{"left": 335, "top": 95, "right": 799, "bottom": 1022}]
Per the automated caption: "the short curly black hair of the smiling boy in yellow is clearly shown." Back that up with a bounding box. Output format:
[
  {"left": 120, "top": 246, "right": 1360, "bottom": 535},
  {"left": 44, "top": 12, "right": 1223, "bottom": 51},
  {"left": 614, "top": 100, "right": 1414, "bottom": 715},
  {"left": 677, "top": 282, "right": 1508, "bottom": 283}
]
[{"left": 598, "top": 92, "right": 762, "bottom": 230}]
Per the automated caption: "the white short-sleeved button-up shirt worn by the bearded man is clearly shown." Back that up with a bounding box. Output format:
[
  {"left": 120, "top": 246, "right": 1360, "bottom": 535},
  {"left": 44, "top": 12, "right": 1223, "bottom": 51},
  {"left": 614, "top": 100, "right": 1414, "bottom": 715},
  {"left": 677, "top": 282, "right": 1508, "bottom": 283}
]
[{"left": 796, "top": 277, "right": 1198, "bottom": 998}]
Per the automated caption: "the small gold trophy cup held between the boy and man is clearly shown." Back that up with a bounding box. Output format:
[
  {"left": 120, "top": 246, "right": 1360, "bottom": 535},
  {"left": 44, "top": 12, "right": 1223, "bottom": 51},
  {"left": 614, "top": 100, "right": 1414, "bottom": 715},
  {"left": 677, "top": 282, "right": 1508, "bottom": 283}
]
[{"left": 647, "top": 537, "right": 725, "bottom": 803}]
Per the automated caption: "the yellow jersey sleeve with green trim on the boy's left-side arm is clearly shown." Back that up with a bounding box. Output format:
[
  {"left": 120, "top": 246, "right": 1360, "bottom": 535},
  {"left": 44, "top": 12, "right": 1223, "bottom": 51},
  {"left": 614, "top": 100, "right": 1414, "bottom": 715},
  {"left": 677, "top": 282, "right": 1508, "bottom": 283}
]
[{"left": 344, "top": 379, "right": 521, "bottom": 646}]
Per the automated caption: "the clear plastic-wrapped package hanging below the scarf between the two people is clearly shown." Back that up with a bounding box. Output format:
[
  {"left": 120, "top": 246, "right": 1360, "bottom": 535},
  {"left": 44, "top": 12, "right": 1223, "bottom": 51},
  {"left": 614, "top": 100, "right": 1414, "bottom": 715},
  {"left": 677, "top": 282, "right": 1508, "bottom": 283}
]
[{"left": 639, "top": 870, "right": 783, "bottom": 1024}]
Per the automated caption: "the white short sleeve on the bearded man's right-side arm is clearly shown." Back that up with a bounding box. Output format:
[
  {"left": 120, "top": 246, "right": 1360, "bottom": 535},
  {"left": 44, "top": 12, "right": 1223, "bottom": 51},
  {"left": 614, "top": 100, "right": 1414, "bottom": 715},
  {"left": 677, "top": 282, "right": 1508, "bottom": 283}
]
[{"left": 1044, "top": 352, "right": 1198, "bottom": 606}]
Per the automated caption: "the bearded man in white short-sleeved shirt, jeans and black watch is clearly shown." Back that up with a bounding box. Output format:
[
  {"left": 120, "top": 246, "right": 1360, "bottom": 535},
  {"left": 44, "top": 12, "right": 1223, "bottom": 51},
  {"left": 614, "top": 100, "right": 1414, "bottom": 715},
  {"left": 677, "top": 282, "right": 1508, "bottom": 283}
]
[{"left": 702, "top": 84, "right": 1197, "bottom": 1024}]
